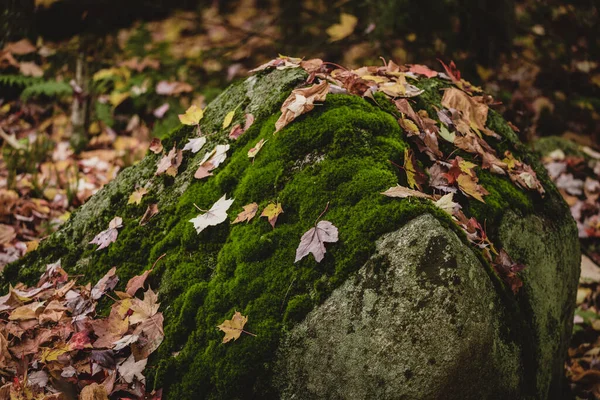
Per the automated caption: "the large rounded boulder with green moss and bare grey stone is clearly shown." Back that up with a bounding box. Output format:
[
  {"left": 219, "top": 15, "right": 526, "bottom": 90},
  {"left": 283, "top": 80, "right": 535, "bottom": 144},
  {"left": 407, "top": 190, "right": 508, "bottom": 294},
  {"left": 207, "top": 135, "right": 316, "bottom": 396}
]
[{"left": 0, "top": 69, "right": 579, "bottom": 399}]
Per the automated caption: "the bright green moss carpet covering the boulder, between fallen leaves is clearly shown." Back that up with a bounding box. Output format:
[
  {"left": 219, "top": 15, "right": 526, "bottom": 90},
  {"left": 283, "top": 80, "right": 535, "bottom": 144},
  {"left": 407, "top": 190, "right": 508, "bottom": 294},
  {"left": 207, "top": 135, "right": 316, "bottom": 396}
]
[{"left": 1, "top": 70, "right": 572, "bottom": 399}]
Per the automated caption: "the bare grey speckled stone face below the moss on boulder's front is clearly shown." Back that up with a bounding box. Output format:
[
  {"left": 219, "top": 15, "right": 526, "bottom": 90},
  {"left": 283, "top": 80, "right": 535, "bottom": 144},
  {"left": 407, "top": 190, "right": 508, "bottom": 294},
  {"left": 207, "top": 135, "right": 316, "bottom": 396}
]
[{"left": 275, "top": 214, "right": 524, "bottom": 400}]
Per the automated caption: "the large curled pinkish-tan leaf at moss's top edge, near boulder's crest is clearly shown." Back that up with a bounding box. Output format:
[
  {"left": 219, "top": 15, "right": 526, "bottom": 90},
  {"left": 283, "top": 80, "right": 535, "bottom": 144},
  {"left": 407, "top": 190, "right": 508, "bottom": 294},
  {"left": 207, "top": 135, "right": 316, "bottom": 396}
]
[{"left": 275, "top": 80, "right": 329, "bottom": 133}]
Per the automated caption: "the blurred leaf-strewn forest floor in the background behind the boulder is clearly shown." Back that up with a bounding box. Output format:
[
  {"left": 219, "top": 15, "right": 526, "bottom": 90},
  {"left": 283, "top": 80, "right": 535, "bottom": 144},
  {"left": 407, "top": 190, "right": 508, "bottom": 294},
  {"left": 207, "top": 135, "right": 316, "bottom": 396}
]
[{"left": 0, "top": 1, "right": 600, "bottom": 399}]
